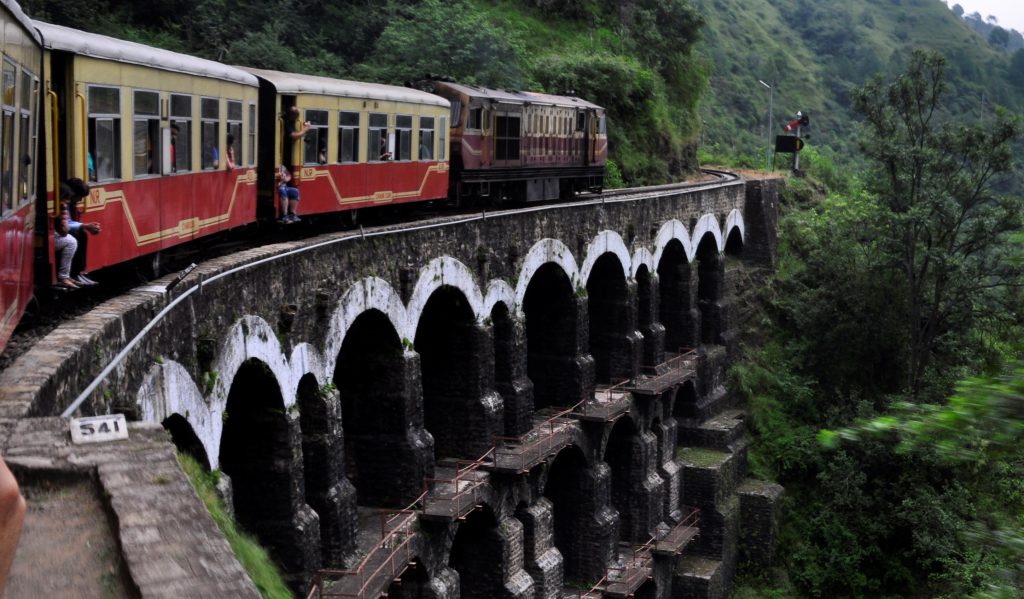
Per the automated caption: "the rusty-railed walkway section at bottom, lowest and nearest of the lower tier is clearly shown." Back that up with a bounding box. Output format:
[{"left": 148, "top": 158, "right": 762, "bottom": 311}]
[{"left": 307, "top": 494, "right": 426, "bottom": 599}]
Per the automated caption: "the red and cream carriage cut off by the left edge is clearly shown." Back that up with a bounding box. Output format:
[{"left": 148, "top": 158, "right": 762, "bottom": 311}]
[{"left": 0, "top": 0, "right": 42, "bottom": 348}]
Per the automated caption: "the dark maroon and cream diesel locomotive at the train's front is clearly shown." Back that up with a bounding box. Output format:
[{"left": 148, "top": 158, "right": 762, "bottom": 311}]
[{"left": 425, "top": 81, "right": 608, "bottom": 202}]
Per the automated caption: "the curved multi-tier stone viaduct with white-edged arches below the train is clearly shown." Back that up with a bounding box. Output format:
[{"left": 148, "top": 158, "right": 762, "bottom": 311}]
[{"left": 5, "top": 176, "right": 778, "bottom": 599}]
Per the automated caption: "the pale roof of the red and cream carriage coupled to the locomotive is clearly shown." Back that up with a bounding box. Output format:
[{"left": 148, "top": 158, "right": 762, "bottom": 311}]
[{"left": 242, "top": 67, "right": 452, "bottom": 109}]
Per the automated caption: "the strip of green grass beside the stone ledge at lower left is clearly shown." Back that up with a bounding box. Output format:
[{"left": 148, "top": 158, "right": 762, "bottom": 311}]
[{"left": 178, "top": 453, "right": 293, "bottom": 599}]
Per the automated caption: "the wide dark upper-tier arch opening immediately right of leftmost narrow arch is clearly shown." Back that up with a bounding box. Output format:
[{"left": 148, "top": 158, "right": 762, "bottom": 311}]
[{"left": 333, "top": 309, "right": 434, "bottom": 507}]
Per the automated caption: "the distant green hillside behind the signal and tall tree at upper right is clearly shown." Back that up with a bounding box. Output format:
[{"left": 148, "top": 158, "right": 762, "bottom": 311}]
[{"left": 695, "top": 0, "right": 1024, "bottom": 163}]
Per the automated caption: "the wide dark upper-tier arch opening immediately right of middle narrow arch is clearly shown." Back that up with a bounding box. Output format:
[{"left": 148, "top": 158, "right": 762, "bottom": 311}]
[{"left": 522, "top": 262, "right": 589, "bottom": 408}]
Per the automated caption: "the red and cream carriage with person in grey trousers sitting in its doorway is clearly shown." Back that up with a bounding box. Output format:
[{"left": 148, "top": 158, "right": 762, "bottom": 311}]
[{"left": 36, "top": 22, "right": 259, "bottom": 270}]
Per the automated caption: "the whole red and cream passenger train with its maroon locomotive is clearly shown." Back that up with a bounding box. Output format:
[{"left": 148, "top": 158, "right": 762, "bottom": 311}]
[{"left": 0, "top": 0, "right": 608, "bottom": 350}]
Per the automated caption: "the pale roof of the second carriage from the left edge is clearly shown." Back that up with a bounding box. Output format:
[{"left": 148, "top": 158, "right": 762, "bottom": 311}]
[{"left": 33, "top": 20, "right": 259, "bottom": 87}]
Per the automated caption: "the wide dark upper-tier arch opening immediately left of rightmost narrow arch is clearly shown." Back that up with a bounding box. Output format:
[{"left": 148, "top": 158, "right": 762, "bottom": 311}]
[{"left": 587, "top": 251, "right": 640, "bottom": 383}]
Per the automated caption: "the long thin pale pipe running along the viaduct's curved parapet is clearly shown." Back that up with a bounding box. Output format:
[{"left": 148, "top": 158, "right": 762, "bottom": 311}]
[{"left": 60, "top": 172, "right": 742, "bottom": 418}]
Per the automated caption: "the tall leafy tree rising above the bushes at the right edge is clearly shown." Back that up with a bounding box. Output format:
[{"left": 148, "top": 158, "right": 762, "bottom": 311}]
[{"left": 854, "top": 50, "right": 1024, "bottom": 397}]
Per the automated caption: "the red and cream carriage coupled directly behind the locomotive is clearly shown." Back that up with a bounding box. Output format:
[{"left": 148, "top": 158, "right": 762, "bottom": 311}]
[{"left": 247, "top": 69, "right": 449, "bottom": 215}]
